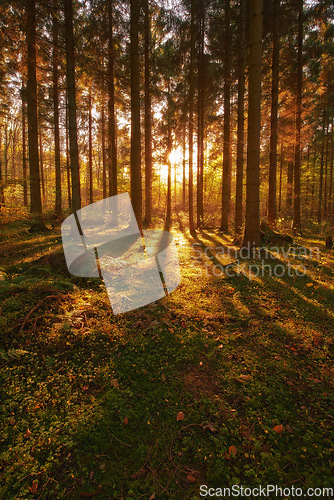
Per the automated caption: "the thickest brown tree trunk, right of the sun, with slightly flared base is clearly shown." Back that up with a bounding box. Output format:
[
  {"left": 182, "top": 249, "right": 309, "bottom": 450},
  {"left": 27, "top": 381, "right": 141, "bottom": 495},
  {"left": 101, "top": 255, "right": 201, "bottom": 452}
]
[{"left": 243, "top": 0, "right": 263, "bottom": 248}]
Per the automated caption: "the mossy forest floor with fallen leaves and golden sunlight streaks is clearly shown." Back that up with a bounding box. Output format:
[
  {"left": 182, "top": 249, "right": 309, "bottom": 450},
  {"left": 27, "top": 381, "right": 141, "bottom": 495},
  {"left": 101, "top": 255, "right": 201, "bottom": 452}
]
[{"left": 0, "top": 213, "right": 334, "bottom": 500}]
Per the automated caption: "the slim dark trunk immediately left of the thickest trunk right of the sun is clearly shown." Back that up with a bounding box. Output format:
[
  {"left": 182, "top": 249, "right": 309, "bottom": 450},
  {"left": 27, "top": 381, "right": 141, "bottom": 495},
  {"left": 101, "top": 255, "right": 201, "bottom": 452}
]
[{"left": 234, "top": 0, "right": 246, "bottom": 235}]
